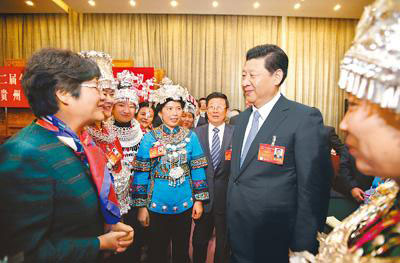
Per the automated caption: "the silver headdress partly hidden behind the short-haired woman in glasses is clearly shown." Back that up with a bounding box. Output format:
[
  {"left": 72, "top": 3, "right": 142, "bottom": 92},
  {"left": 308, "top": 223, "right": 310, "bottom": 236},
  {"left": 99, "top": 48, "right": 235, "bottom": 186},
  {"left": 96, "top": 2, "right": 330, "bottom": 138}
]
[{"left": 79, "top": 50, "right": 118, "bottom": 90}]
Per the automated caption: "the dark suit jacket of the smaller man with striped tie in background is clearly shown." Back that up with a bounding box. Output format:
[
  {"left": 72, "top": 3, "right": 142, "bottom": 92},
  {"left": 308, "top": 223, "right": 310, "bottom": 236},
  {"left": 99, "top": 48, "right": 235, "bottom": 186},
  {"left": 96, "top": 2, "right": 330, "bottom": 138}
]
[{"left": 194, "top": 124, "right": 233, "bottom": 214}]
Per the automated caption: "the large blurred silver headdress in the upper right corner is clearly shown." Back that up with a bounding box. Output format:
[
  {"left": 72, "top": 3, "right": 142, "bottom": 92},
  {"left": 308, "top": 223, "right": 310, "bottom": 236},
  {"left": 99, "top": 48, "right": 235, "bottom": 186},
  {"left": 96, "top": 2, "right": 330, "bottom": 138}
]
[{"left": 339, "top": 0, "right": 400, "bottom": 113}]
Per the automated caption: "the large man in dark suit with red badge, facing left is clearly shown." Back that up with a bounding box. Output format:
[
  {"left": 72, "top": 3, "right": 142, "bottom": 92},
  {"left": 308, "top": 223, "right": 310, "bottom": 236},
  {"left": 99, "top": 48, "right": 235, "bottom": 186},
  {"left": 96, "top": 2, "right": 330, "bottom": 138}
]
[{"left": 227, "top": 45, "right": 333, "bottom": 263}]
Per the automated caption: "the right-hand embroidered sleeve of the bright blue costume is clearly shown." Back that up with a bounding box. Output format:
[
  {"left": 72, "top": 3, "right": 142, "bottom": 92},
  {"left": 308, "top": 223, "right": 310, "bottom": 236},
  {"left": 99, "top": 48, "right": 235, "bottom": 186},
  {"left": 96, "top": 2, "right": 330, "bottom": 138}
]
[{"left": 190, "top": 132, "right": 210, "bottom": 201}]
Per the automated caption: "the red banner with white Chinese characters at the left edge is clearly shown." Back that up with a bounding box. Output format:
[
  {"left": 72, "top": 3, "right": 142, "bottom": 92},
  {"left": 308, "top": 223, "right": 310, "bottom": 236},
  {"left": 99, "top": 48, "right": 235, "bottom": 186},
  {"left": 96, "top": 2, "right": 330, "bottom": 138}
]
[{"left": 0, "top": 67, "right": 29, "bottom": 108}]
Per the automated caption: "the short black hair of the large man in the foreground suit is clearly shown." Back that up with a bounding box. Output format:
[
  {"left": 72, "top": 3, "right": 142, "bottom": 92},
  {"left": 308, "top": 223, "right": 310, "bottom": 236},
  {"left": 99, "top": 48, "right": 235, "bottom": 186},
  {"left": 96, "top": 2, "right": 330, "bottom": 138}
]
[{"left": 246, "top": 44, "right": 289, "bottom": 86}]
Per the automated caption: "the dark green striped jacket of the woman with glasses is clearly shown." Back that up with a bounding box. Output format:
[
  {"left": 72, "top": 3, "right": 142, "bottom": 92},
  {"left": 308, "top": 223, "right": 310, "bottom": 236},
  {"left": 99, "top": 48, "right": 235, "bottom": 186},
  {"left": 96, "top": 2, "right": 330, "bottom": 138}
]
[{"left": 0, "top": 124, "right": 104, "bottom": 263}]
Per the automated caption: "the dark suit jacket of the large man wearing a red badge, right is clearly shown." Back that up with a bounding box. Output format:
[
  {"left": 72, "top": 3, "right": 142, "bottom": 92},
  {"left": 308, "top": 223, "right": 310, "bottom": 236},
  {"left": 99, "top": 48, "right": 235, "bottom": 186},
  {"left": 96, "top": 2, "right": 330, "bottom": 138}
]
[{"left": 227, "top": 95, "right": 333, "bottom": 263}]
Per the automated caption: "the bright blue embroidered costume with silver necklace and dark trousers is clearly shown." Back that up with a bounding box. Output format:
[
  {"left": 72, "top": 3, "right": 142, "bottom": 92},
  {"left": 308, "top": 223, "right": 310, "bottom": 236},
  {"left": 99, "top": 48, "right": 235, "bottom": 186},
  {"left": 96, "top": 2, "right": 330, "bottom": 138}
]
[{"left": 132, "top": 124, "right": 209, "bottom": 263}]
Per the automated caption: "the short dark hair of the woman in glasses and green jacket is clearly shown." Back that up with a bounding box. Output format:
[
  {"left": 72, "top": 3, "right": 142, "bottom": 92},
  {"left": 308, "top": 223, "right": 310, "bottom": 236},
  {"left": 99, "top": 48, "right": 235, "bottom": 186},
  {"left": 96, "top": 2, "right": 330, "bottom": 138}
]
[{"left": 21, "top": 48, "right": 101, "bottom": 118}]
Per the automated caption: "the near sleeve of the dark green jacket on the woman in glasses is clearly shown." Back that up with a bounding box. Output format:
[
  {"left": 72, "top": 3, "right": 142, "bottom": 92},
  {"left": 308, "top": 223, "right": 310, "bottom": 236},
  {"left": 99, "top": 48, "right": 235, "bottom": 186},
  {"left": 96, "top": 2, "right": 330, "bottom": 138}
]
[{"left": 0, "top": 141, "right": 100, "bottom": 262}]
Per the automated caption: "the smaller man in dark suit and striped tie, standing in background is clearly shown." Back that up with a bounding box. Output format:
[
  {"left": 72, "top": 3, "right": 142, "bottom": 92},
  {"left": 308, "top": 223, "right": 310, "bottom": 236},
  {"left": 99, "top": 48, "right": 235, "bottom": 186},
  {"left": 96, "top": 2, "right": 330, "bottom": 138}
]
[{"left": 193, "top": 92, "right": 233, "bottom": 263}]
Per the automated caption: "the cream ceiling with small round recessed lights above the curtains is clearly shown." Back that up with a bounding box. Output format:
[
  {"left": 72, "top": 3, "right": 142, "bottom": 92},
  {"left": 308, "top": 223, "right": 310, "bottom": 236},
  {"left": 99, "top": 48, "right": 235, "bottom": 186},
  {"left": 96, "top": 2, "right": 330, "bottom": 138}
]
[{"left": 0, "top": 0, "right": 373, "bottom": 18}]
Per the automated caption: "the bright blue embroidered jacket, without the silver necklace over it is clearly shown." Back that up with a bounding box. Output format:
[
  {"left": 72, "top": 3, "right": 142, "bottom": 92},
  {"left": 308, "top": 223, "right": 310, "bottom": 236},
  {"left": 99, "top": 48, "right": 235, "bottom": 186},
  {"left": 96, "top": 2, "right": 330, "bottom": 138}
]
[{"left": 132, "top": 125, "right": 209, "bottom": 214}]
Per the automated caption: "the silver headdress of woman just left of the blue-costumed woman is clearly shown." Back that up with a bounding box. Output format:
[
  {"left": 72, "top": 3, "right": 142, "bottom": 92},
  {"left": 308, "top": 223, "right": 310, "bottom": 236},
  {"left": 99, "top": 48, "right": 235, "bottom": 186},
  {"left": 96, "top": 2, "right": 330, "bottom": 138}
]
[{"left": 115, "top": 70, "right": 139, "bottom": 108}]
